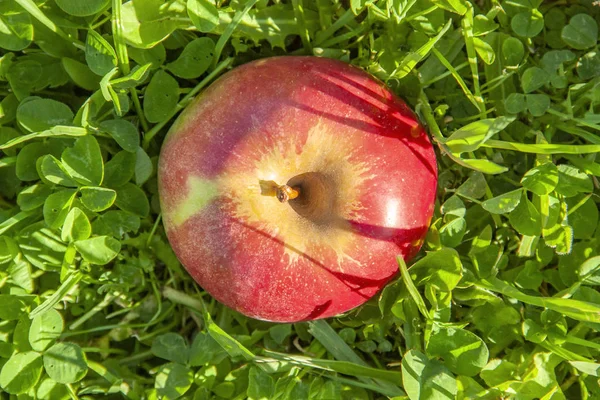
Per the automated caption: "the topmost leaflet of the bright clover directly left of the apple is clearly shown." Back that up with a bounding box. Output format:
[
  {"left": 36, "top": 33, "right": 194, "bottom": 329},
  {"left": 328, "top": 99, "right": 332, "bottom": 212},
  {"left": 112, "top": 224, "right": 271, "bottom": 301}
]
[{"left": 61, "top": 135, "right": 104, "bottom": 186}]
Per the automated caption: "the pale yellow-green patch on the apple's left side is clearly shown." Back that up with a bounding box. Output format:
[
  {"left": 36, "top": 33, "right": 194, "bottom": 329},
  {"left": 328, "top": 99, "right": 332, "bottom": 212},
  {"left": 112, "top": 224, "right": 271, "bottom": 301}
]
[{"left": 163, "top": 175, "right": 219, "bottom": 228}]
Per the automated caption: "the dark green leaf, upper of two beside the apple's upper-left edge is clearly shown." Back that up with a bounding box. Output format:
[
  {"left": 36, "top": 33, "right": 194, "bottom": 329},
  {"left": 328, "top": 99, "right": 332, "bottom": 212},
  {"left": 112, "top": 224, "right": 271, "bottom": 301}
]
[{"left": 166, "top": 37, "right": 215, "bottom": 79}]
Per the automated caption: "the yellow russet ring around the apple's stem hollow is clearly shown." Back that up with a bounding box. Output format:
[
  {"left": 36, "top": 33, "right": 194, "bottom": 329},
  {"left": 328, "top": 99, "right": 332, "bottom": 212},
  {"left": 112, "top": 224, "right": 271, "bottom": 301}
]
[{"left": 220, "top": 119, "right": 372, "bottom": 270}]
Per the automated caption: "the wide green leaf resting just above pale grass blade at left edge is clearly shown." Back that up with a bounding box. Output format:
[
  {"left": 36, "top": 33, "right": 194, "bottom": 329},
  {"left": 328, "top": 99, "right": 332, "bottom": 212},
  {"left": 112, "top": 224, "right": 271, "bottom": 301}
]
[{"left": 17, "top": 97, "right": 74, "bottom": 132}]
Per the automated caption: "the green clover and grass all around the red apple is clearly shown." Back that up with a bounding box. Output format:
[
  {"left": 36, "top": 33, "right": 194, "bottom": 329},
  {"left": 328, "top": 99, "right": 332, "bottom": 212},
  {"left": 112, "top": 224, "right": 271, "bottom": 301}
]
[{"left": 0, "top": 0, "right": 600, "bottom": 400}]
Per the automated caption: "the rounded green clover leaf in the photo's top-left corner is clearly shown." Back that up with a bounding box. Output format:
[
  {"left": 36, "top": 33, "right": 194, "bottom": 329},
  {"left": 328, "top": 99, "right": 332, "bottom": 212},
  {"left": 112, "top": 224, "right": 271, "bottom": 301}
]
[{"left": 0, "top": 1, "right": 33, "bottom": 51}]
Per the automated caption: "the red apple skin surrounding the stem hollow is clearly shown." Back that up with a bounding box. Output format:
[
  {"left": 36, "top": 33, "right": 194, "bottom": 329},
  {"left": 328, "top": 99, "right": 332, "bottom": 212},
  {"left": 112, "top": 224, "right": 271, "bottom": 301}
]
[{"left": 158, "top": 56, "right": 437, "bottom": 322}]
